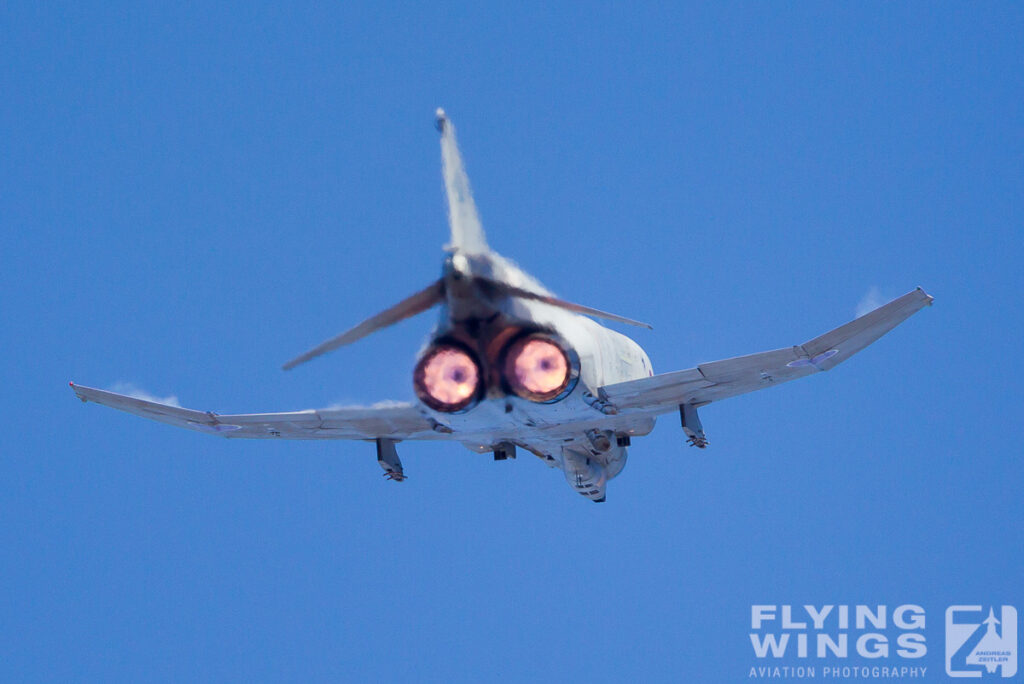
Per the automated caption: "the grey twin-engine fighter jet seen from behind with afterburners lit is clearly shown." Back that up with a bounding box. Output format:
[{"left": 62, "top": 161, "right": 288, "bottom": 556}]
[{"left": 72, "top": 110, "right": 932, "bottom": 502}]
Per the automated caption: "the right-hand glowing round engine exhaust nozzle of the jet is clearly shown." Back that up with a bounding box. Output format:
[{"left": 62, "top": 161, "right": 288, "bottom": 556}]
[{"left": 503, "top": 333, "right": 580, "bottom": 403}]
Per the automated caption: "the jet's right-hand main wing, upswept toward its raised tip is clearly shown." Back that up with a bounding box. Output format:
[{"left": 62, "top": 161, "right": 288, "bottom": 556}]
[{"left": 599, "top": 288, "right": 932, "bottom": 414}]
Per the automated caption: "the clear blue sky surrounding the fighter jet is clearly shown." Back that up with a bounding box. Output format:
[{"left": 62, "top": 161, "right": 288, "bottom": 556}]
[{"left": 0, "top": 2, "right": 1024, "bottom": 682}]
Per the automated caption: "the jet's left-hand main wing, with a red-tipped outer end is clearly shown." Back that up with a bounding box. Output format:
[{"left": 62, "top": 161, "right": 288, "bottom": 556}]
[{"left": 71, "top": 383, "right": 446, "bottom": 439}]
